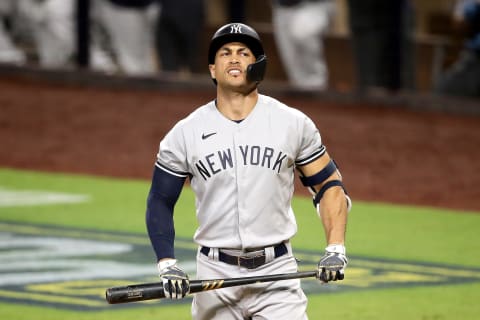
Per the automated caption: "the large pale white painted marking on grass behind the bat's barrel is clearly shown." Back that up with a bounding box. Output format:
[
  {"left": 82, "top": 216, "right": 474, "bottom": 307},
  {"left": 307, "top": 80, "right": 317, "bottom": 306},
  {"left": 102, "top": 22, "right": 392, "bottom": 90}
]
[{"left": 0, "top": 232, "right": 195, "bottom": 288}]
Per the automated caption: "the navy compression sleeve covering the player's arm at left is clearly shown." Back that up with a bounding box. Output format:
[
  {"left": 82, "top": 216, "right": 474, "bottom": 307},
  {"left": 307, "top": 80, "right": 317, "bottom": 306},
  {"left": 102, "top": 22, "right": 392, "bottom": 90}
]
[{"left": 146, "top": 166, "right": 186, "bottom": 261}]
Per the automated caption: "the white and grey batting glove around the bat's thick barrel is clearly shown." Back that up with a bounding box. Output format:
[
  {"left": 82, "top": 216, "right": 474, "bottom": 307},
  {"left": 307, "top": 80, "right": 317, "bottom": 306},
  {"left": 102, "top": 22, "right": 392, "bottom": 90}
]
[{"left": 157, "top": 259, "right": 190, "bottom": 299}]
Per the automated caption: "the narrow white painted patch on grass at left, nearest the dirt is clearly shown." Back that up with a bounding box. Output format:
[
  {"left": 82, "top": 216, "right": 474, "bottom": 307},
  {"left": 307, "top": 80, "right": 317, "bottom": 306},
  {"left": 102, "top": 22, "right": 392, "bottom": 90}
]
[{"left": 0, "top": 188, "right": 90, "bottom": 207}]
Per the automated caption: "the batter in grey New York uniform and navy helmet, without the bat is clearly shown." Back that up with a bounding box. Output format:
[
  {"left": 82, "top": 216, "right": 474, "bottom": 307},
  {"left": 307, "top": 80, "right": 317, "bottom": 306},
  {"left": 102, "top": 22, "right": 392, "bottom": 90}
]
[{"left": 146, "top": 23, "right": 351, "bottom": 320}]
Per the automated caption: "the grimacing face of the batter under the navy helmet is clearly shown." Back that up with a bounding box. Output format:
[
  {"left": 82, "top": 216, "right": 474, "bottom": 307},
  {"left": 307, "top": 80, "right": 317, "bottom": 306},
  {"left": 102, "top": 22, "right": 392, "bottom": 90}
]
[{"left": 209, "top": 42, "right": 255, "bottom": 86}]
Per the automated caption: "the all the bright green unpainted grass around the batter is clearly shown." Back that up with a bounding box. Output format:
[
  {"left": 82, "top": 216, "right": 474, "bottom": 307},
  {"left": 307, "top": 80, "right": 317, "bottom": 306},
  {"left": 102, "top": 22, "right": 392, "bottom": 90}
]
[{"left": 0, "top": 168, "right": 480, "bottom": 320}]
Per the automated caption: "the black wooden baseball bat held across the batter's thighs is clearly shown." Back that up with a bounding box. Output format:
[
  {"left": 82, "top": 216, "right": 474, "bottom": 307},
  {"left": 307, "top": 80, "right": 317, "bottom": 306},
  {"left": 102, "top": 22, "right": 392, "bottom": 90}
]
[{"left": 105, "top": 271, "right": 317, "bottom": 304}]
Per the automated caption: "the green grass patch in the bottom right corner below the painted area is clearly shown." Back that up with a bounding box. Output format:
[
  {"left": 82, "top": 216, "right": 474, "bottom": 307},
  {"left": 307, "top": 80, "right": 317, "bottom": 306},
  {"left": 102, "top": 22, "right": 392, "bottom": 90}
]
[{"left": 309, "top": 282, "right": 480, "bottom": 320}]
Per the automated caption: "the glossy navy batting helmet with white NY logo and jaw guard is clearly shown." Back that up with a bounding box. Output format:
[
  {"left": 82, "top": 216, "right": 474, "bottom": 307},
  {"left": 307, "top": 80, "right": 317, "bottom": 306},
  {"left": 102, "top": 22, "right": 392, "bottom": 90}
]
[{"left": 208, "top": 23, "right": 267, "bottom": 82}]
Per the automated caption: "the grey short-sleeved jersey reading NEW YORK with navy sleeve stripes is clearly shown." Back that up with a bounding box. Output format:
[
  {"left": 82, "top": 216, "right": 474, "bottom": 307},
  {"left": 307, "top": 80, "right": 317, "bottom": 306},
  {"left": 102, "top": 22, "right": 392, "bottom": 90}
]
[{"left": 157, "top": 95, "right": 325, "bottom": 249}]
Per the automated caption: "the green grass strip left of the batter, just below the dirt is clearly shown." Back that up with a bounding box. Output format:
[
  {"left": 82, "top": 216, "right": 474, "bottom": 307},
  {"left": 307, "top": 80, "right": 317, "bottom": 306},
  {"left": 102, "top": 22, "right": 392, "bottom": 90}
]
[{"left": 0, "top": 169, "right": 195, "bottom": 233}]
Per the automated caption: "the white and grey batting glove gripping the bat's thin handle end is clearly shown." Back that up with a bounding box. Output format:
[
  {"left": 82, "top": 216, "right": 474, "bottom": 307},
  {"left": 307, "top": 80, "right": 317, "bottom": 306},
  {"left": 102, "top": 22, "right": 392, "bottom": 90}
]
[{"left": 317, "top": 244, "right": 348, "bottom": 283}]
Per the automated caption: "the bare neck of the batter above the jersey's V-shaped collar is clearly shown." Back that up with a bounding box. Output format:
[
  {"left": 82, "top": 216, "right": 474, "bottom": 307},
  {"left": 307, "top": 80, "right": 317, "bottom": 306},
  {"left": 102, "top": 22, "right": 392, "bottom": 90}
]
[{"left": 216, "top": 90, "right": 258, "bottom": 121}]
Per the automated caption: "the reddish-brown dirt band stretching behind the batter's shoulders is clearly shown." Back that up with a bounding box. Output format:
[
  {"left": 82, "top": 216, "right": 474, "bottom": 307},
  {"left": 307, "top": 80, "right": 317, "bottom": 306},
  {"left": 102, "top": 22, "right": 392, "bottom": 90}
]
[{"left": 0, "top": 72, "right": 480, "bottom": 211}]
